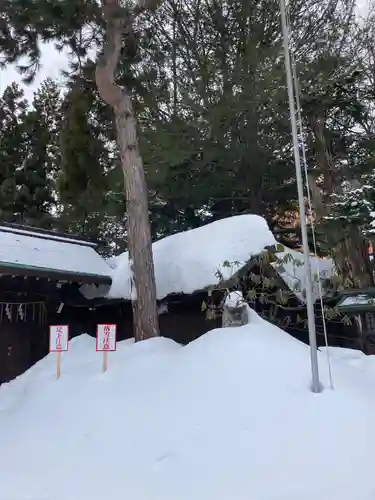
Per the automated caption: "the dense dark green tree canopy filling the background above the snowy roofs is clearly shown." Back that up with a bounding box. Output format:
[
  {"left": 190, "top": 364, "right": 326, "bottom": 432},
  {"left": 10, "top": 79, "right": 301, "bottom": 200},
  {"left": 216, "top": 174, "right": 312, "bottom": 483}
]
[{"left": 0, "top": 0, "right": 375, "bottom": 274}]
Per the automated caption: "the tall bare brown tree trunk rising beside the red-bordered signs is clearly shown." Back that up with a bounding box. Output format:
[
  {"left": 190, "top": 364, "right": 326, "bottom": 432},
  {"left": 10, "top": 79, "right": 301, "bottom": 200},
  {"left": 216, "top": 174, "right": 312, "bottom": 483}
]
[{"left": 96, "top": 0, "right": 159, "bottom": 341}]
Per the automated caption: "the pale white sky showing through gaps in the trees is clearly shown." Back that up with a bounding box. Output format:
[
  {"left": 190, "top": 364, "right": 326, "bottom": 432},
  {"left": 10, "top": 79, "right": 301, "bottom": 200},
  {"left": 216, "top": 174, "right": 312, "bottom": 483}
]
[{"left": 0, "top": 0, "right": 371, "bottom": 101}]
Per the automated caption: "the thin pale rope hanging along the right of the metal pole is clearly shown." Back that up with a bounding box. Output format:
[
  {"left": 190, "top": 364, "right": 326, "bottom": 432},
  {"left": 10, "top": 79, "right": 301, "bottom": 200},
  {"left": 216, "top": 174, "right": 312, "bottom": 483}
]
[{"left": 286, "top": 0, "right": 334, "bottom": 389}]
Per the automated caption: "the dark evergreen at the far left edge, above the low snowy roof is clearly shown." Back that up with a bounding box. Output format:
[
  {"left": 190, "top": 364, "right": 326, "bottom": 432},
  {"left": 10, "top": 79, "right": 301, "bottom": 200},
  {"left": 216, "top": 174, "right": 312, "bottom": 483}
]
[{"left": 0, "top": 85, "right": 53, "bottom": 227}]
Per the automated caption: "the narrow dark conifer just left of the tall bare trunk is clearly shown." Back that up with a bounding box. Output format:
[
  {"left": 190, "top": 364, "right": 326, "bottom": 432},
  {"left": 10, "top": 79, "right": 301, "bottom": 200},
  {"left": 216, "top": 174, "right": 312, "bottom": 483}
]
[{"left": 57, "top": 84, "right": 109, "bottom": 239}]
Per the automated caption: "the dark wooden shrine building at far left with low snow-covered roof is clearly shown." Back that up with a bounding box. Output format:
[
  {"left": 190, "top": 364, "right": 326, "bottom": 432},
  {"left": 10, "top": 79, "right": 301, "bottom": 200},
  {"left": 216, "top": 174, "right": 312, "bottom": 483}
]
[{"left": 0, "top": 224, "right": 111, "bottom": 383}]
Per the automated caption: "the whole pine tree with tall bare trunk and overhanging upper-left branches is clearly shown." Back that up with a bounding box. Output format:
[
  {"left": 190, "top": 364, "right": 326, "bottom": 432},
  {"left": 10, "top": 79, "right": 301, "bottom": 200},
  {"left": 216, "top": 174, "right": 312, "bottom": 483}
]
[{"left": 0, "top": 0, "right": 164, "bottom": 340}]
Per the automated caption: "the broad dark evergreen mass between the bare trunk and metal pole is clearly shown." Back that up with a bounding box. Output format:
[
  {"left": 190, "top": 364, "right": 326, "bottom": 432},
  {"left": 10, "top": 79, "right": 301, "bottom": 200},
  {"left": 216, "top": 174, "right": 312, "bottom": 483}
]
[{"left": 135, "top": 0, "right": 362, "bottom": 233}]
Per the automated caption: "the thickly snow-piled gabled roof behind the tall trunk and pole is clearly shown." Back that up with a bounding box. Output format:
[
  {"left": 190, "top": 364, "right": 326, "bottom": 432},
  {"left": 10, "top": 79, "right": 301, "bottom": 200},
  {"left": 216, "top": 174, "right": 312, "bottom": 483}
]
[{"left": 108, "top": 214, "right": 335, "bottom": 301}]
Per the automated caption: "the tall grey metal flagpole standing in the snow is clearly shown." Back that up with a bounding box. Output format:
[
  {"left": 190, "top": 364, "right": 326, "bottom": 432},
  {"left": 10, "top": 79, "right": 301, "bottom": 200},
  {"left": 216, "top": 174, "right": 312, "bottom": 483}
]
[{"left": 280, "top": 0, "right": 322, "bottom": 393}]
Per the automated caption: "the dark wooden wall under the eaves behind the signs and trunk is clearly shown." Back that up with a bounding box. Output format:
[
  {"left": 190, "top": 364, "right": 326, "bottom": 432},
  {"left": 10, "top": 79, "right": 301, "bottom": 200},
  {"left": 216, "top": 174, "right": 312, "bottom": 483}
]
[{"left": 0, "top": 294, "right": 220, "bottom": 384}]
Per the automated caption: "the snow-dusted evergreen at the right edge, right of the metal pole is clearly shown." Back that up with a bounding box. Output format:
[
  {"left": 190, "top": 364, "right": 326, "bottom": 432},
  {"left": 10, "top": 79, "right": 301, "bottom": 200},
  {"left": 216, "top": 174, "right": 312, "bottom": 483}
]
[{"left": 302, "top": 8, "right": 374, "bottom": 288}]
